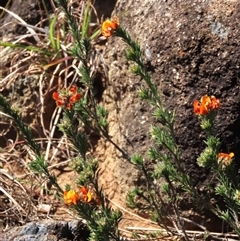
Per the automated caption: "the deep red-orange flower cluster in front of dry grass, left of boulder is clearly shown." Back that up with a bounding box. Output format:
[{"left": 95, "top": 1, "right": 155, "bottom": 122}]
[{"left": 52, "top": 86, "right": 82, "bottom": 110}]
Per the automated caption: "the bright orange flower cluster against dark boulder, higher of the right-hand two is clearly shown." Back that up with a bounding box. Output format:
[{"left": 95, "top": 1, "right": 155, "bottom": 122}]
[{"left": 193, "top": 95, "right": 220, "bottom": 115}]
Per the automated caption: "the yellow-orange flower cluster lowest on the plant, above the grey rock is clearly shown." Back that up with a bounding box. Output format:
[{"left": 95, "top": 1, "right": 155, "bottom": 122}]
[{"left": 63, "top": 186, "right": 100, "bottom": 205}]
